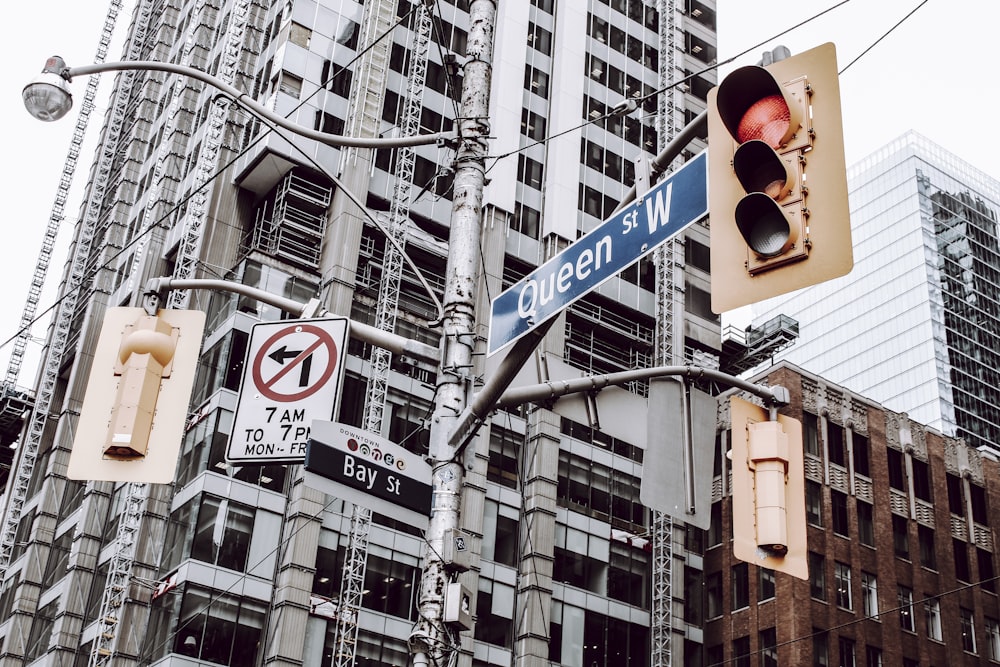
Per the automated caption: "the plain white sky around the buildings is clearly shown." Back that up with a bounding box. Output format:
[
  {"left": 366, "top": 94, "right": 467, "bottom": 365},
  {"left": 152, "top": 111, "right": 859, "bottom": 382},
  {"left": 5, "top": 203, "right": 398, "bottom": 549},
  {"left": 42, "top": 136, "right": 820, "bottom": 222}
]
[{"left": 0, "top": 0, "right": 1000, "bottom": 384}]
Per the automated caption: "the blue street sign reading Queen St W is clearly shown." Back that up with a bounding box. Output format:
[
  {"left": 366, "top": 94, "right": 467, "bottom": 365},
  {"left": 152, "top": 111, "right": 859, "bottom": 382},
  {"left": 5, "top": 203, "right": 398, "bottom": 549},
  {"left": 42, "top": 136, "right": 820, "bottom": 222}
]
[{"left": 487, "top": 151, "right": 708, "bottom": 354}]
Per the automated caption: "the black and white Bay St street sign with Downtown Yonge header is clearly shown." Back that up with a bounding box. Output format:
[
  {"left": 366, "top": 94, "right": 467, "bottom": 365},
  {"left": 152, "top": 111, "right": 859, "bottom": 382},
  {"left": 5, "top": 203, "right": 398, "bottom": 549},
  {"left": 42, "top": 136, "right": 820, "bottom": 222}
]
[{"left": 305, "top": 420, "right": 431, "bottom": 530}]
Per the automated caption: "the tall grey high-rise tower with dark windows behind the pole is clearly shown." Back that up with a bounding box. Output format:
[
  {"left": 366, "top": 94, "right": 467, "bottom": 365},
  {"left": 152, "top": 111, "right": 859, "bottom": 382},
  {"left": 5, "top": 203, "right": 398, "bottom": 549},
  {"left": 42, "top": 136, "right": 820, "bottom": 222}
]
[{"left": 0, "top": 0, "right": 719, "bottom": 667}]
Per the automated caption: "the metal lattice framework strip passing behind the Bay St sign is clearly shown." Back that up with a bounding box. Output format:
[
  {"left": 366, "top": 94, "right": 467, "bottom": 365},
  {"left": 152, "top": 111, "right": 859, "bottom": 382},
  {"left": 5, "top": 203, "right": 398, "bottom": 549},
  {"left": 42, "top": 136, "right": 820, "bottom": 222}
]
[{"left": 333, "top": 3, "right": 431, "bottom": 667}]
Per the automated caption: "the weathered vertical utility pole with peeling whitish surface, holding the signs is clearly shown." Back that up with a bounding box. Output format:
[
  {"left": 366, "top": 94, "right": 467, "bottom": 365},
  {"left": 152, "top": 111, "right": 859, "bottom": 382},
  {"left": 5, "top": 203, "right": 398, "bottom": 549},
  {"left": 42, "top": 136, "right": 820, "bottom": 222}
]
[{"left": 409, "top": 0, "right": 496, "bottom": 667}]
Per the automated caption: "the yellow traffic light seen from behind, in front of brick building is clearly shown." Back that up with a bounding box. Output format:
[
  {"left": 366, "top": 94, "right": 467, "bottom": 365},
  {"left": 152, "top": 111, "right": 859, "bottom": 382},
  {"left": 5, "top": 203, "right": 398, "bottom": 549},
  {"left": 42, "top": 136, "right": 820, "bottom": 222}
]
[{"left": 729, "top": 396, "right": 809, "bottom": 579}]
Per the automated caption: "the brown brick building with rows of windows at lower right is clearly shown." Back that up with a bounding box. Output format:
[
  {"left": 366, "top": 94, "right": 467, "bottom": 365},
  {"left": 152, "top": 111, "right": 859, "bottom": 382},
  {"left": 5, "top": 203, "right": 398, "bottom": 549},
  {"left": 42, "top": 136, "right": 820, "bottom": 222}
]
[{"left": 704, "top": 362, "right": 1000, "bottom": 667}]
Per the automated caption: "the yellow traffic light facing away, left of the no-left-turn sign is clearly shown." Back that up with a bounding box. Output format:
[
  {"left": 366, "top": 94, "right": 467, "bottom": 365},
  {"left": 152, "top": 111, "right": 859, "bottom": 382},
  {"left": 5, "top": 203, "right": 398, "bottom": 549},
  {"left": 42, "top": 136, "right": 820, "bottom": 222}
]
[{"left": 67, "top": 308, "right": 205, "bottom": 483}]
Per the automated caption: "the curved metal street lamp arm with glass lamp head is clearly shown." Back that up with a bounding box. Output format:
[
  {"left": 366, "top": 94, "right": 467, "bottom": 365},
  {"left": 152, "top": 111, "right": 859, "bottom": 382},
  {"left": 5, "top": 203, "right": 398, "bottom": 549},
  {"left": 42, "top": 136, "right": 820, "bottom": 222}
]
[{"left": 22, "top": 56, "right": 457, "bottom": 149}]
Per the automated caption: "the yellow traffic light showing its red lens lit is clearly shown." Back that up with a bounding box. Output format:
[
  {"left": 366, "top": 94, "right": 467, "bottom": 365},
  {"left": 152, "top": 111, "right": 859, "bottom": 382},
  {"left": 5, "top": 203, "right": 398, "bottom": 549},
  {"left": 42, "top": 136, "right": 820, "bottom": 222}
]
[{"left": 708, "top": 43, "right": 854, "bottom": 313}]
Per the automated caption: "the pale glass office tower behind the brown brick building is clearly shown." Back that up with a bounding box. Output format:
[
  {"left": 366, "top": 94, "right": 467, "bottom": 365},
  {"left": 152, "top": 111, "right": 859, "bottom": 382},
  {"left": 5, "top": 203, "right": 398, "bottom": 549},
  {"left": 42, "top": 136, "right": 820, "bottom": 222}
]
[{"left": 754, "top": 132, "right": 1000, "bottom": 451}]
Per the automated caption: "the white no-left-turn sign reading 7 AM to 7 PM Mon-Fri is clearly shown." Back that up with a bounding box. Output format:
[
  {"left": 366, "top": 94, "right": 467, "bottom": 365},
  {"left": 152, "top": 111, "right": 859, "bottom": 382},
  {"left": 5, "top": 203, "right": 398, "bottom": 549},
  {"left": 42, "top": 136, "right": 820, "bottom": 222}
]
[{"left": 226, "top": 318, "right": 349, "bottom": 465}]
